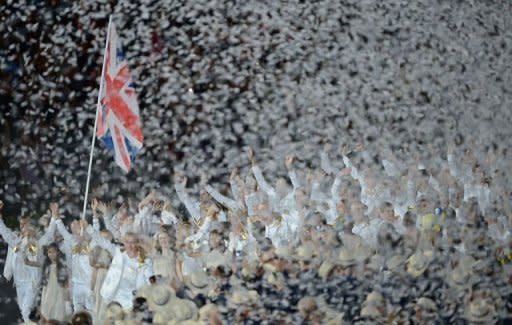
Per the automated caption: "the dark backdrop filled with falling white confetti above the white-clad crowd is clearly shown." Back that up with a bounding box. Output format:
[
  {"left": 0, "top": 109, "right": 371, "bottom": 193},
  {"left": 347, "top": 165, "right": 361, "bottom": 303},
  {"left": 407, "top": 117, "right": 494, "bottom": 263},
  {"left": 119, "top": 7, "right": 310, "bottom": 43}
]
[{"left": 0, "top": 0, "right": 512, "bottom": 216}]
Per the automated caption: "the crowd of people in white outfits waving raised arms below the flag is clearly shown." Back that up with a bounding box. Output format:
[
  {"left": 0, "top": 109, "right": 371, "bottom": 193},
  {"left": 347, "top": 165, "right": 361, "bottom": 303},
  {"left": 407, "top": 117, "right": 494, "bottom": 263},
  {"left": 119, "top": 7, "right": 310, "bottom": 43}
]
[{"left": 0, "top": 145, "right": 512, "bottom": 324}]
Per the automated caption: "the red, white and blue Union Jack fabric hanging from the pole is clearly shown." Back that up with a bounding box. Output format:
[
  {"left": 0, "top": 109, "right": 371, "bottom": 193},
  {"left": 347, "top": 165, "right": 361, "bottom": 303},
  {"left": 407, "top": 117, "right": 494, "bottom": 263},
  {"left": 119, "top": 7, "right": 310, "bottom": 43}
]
[{"left": 96, "top": 18, "right": 143, "bottom": 172}]
